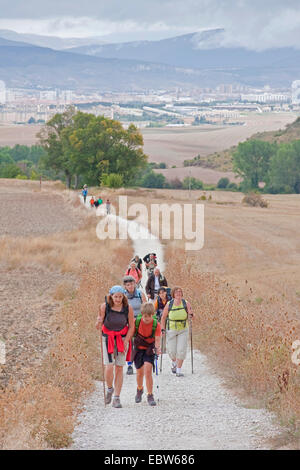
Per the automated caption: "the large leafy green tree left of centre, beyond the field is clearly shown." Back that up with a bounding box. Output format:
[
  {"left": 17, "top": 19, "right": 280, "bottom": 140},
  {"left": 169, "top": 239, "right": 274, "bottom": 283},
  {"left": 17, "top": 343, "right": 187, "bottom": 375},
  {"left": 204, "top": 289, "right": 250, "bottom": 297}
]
[{"left": 40, "top": 109, "right": 147, "bottom": 186}]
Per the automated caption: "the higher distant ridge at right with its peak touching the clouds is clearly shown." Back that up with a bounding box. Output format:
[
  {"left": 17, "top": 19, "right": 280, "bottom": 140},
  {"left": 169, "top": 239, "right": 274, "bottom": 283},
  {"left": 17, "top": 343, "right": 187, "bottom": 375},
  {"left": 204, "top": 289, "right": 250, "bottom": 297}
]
[{"left": 71, "top": 28, "right": 300, "bottom": 70}]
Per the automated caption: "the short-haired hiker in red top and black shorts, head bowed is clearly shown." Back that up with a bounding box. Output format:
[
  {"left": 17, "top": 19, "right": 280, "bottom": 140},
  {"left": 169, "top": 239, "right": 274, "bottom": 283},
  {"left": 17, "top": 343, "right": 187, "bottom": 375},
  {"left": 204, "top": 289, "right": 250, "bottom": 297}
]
[{"left": 132, "top": 302, "right": 161, "bottom": 406}]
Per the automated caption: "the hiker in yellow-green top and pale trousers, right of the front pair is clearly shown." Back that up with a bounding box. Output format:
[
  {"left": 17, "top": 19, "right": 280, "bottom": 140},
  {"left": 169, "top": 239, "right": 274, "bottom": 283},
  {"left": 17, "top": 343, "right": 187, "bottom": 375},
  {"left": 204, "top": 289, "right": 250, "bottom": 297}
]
[{"left": 161, "top": 287, "right": 193, "bottom": 377}]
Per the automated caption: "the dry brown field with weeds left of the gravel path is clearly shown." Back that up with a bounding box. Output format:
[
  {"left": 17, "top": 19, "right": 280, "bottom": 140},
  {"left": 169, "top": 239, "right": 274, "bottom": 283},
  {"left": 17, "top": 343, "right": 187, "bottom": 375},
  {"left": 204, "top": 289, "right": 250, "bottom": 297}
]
[{"left": 0, "top": 180, "right": 132, "bottom": 449}]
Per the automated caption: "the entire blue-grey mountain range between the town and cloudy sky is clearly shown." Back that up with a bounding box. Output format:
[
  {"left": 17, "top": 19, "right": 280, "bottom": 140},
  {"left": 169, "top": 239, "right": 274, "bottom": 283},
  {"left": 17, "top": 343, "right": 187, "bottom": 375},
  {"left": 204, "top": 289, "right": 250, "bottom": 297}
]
[{"left": 0, "top": 29, "right": 300, "bottom": 91}]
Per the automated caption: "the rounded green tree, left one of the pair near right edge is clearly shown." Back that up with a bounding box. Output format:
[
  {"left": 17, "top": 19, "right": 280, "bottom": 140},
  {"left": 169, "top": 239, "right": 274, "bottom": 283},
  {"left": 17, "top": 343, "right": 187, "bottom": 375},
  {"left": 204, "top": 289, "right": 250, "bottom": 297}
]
[{"left": 233, "top": 140, "right": 277, "bottom": 188}]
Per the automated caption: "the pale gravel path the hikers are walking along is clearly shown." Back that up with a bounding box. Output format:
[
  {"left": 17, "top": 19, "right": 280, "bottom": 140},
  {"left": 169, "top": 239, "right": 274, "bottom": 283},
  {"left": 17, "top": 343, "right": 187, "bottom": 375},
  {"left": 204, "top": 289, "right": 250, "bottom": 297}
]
[{"left": 72, "top": 196, "right": 282, "bottom": 450}]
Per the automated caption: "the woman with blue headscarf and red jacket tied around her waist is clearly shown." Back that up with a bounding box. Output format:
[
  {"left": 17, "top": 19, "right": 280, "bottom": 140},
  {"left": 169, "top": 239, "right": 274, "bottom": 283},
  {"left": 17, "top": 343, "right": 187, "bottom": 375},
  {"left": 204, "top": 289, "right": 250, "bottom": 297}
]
[{"left": 96, "top": 286, "right": 135, "bottom": 408}]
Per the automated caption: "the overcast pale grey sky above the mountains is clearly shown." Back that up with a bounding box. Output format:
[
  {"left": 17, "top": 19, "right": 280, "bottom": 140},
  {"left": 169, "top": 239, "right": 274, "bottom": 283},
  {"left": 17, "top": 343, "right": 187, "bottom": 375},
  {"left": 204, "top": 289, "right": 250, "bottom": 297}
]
[{"left": 0, "top": 0, "right": 300, "bottom": 49}]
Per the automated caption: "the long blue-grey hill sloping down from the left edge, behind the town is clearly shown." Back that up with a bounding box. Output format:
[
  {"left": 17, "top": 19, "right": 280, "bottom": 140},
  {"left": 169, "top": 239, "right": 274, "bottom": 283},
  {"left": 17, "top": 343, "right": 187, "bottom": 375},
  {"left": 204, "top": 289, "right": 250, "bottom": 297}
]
[{"left": 0, "top": 40, "right": 232, "bottom": 91}]
